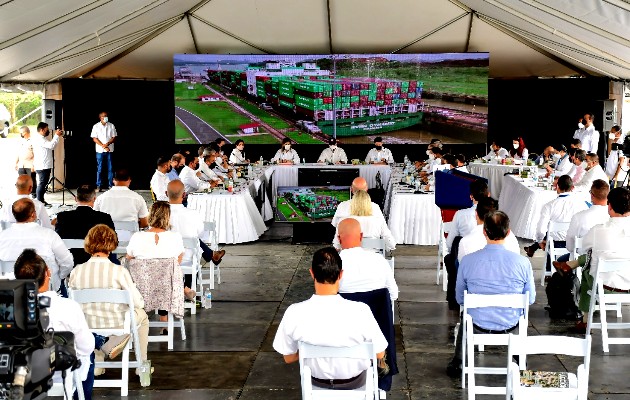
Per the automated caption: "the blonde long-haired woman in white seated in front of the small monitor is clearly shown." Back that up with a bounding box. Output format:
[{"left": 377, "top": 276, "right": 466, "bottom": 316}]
[{"left": 333, "top": 190, "right": 396, "bottom": 251}]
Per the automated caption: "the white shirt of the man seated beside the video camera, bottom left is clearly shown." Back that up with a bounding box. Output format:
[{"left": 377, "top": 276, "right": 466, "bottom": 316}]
[{"left": 39, "top": 291, "right": 94, "bottom": 380}]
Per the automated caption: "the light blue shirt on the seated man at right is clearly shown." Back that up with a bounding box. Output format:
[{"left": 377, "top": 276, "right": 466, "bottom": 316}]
[{"left": 455, "top": 244, "right": 536, "bottom": 331}]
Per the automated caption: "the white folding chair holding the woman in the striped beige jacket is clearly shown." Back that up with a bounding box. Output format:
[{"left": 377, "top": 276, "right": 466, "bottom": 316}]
[{"left": 69, "top": 289, "right": 142, "bottom": 397}]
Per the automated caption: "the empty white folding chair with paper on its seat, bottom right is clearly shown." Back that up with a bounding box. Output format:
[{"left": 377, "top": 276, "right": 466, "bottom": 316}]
[{"left": 505, "top": 334, "right": 591, "bottom": 400}]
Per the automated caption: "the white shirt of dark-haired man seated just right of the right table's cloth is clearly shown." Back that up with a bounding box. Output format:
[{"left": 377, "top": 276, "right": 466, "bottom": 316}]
[{"left": 536, "top": 193, "right": 588, "bottom": 242}]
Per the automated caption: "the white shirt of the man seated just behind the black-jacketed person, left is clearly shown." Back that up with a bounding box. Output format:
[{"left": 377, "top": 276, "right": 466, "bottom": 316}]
[{"left": 94, "top": 186, "right": 149, "bottom": 221}]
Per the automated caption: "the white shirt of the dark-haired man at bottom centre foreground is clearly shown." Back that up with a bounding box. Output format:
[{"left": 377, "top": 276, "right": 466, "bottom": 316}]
[{"left": 273, "top": 294, "right": 387, "bottom": 379}]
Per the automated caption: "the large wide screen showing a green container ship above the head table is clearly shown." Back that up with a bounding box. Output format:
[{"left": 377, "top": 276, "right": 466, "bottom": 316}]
[{"left": 173, "top": 53, "right": 489, "bottom": 144}]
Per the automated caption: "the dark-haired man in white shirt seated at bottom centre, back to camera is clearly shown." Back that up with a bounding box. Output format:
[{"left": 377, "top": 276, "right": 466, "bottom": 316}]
[{"left": 273, "top": 247, "right": 389, "bottom": 389}]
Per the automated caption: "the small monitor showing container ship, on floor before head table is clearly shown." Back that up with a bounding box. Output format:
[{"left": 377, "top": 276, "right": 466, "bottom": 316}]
[{"left": 275, "top": 186, "right": 350, "bottom": 222}]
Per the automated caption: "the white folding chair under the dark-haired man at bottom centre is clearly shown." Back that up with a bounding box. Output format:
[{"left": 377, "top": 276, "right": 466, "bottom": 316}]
[{"left": 298, "top": 342, "right": 378, "bottom": 400}]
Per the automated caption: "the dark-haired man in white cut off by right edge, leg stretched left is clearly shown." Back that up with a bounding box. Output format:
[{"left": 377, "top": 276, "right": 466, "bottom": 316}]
[{"left": 554, "top": 188, "right": 630, "bottom": 333}]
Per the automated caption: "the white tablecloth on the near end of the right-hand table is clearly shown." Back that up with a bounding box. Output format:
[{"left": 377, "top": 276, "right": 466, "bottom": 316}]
[{"left": 499, "top": 175, "right": 558, "bottom": 240}]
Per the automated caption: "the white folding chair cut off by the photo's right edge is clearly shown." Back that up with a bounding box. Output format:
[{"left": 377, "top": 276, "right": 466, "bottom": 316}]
[{"left": 586, "top": 258, "right": 630, "bottom": 353}]
